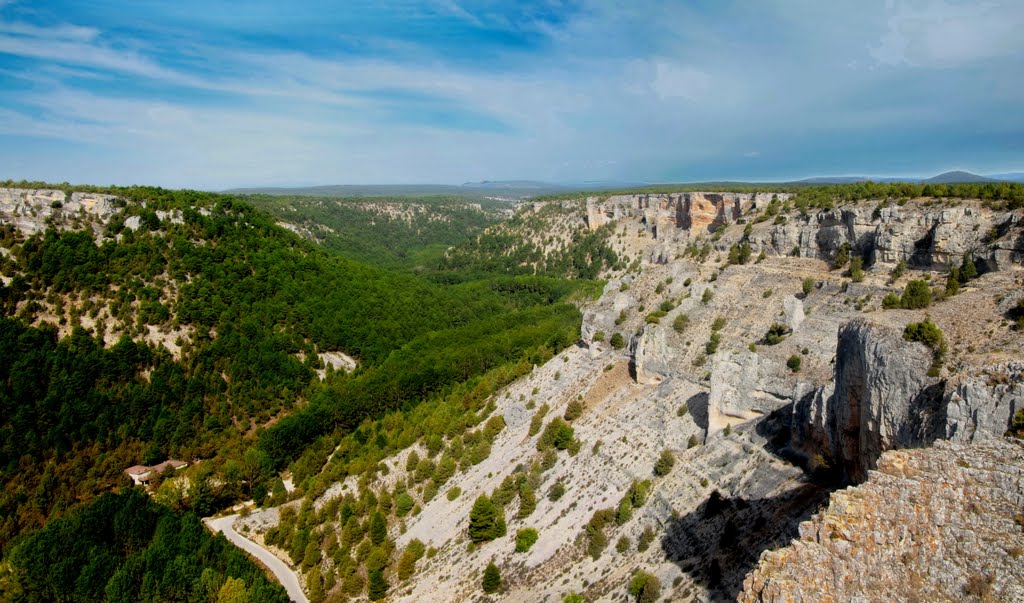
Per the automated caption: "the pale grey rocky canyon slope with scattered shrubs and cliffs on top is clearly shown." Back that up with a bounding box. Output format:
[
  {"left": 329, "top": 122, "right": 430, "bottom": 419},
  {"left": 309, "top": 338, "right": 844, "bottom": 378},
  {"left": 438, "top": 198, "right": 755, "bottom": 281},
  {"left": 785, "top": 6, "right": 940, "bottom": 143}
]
[{"left": 232, "top": 193, "right": 1024, "bottom": 601}]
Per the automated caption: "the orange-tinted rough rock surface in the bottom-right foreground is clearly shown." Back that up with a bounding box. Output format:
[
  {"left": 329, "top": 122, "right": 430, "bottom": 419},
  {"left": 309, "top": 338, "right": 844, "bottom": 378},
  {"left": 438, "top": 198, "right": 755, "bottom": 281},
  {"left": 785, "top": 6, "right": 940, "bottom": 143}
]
[{"left": 738, "top": 439, "right": 1024, "bottom": 603}]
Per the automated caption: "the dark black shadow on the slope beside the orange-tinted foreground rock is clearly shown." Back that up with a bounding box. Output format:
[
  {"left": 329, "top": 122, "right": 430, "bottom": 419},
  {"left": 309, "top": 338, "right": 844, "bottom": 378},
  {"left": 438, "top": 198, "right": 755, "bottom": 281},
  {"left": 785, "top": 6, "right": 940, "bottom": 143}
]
[{"left": 662, "top": 483, "right": 830, "bottom": 601}]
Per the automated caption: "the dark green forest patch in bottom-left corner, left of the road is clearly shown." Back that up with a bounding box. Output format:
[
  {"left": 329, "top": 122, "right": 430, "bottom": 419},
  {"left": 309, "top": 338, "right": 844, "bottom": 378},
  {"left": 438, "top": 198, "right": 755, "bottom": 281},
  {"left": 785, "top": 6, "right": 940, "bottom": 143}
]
[{"left": 0, "top": 489, "right": 289, "bottom": 603}]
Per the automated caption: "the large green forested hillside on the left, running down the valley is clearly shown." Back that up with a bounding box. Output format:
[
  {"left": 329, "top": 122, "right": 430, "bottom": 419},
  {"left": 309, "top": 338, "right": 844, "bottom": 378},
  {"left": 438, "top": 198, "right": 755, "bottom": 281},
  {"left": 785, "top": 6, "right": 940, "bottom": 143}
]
[{"left": 0, "top": 182, "right": 593, "bottom": 600}]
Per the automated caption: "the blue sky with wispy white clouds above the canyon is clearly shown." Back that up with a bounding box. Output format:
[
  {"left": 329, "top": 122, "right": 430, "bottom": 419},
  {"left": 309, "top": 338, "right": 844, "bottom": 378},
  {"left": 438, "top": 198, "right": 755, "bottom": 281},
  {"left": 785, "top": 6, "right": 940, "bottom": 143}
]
[{"left": 0, "top": 0, "right": 1024, "bottom": 189}]
